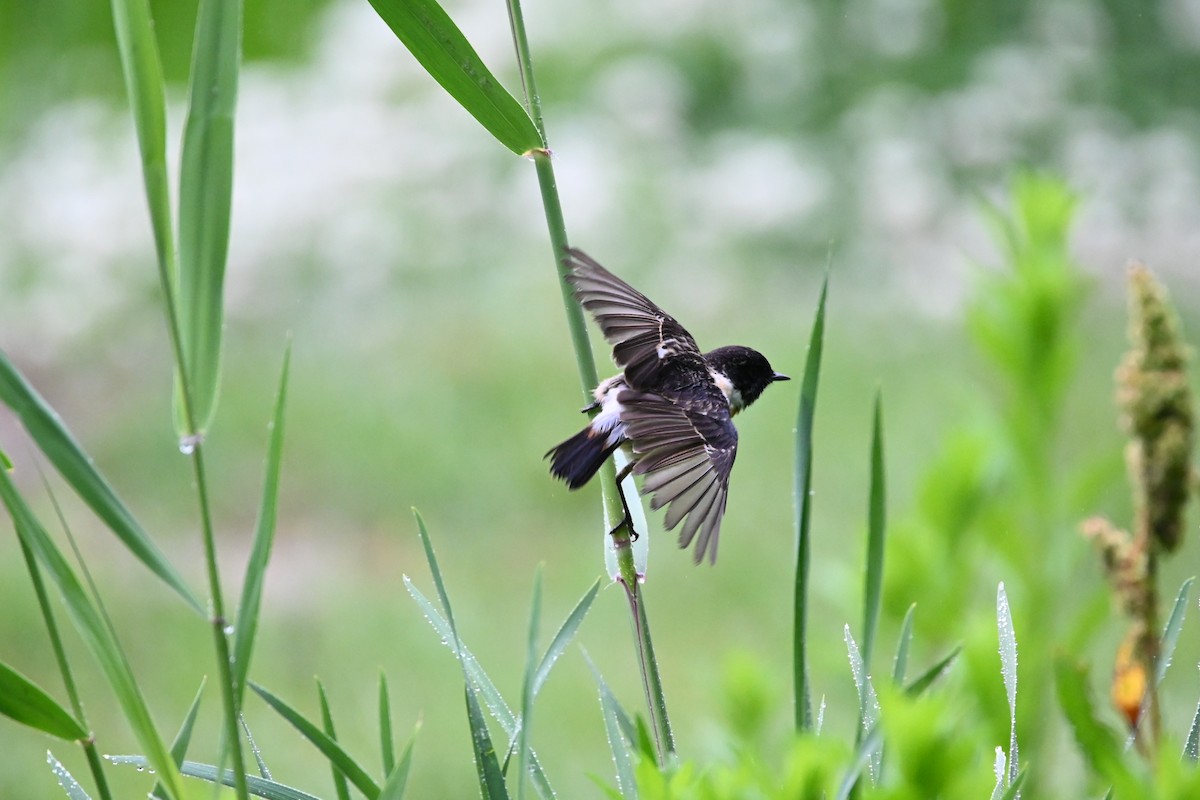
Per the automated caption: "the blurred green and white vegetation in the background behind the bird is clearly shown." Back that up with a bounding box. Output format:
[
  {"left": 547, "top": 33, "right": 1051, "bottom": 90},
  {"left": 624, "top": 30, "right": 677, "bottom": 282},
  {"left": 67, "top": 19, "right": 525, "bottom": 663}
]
[{"left": 0, "top": 0, "right": 1200, "bottom": 798}]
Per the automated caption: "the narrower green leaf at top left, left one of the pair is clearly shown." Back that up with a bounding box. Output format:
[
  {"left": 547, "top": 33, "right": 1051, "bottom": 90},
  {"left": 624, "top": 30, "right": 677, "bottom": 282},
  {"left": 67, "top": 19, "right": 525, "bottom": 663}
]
[{"left": 112, "top": 0, "right": 175, "bottom": 306}]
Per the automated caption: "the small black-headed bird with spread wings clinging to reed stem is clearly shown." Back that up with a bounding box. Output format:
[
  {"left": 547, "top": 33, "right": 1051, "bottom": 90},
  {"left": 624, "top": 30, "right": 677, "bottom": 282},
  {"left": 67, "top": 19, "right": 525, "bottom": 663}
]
[{"left": 546, "top": 248, "right": 790, "bottom": 564}]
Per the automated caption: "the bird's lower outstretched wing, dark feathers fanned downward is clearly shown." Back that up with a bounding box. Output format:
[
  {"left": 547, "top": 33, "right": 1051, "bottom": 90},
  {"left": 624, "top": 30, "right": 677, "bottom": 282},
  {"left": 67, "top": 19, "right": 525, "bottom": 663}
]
[{"left": 618, "top": 385, "right": 738, "bottom": 564}]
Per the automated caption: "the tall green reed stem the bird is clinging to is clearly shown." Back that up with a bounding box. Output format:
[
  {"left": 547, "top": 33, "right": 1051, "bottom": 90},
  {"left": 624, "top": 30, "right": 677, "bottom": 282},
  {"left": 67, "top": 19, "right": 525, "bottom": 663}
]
[{"left": 506, "top": 0, "right": 674, "bottom": 763}]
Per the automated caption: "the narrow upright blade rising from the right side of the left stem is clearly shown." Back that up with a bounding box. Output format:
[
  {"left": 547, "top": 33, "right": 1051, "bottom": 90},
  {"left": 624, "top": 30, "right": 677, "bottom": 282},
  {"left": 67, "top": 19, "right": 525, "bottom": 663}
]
[{"left": 233, "top": 343, "right": 292, "bottom": 708}]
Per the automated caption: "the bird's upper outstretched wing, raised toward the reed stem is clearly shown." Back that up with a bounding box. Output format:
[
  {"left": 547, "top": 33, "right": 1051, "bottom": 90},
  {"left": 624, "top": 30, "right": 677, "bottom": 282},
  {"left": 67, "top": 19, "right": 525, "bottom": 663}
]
[{"left": 565, "top": 248, "right": 712, "bottom": 391}]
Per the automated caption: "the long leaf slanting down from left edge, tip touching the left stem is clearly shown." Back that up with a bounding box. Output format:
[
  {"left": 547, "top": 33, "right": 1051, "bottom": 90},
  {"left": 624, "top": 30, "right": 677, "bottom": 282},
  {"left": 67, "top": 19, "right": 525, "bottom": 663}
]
[{"left": 0, "top": 353, "right": 204, "bottom": 615}]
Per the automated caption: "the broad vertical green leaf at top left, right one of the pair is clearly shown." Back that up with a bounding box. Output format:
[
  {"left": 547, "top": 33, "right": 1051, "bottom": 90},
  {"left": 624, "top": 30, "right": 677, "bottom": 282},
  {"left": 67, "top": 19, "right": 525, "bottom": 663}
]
[{"left": 178, "top": 0, "right": 241, "bottom": 437}]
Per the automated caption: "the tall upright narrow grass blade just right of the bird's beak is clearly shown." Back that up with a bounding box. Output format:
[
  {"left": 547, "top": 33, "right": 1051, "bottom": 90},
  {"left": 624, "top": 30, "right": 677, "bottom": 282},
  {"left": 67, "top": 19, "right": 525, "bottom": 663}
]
[{"left": 792, "top": 272, "right": 829, "bottom": 730}]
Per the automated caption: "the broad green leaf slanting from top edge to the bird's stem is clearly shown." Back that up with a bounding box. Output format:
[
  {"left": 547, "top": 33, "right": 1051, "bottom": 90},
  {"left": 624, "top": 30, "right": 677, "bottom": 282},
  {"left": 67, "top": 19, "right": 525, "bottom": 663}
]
[{"left": 371, "top": 0, "right": 544, "bottom": 155}]
